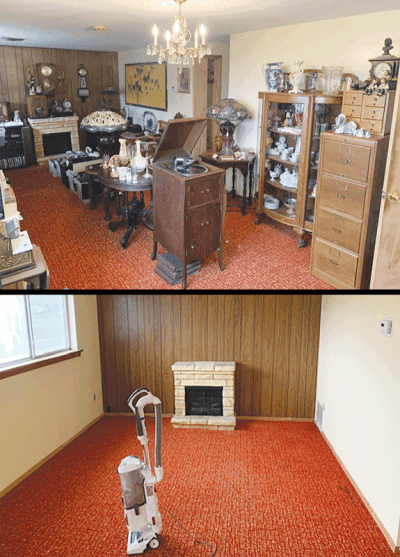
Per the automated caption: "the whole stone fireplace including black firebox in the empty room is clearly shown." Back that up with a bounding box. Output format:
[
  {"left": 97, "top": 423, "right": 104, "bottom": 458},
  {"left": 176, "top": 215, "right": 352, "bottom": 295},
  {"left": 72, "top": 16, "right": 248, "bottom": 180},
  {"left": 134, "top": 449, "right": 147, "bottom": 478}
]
[{"left": 171, "top": 362, "right": 236, "bottom": 431}]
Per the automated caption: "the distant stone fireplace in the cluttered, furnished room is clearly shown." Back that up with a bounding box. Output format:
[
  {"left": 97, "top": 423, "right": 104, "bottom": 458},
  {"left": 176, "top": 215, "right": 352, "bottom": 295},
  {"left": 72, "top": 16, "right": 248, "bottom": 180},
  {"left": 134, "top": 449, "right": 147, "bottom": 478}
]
[{"left": 28, "top": 116, "right": 79, "bottom": 164}]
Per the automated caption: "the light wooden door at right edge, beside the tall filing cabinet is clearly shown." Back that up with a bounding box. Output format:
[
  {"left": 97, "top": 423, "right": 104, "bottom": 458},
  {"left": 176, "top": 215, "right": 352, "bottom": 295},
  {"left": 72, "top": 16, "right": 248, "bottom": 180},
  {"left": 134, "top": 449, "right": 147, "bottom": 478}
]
[{"left": 370, "top": 87, "right": 400, "bottom": 290}]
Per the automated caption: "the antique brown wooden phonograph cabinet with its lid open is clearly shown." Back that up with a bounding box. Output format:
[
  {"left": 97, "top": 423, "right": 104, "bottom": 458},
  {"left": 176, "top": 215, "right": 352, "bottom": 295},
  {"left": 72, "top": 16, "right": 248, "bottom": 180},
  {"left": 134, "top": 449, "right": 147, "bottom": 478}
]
[{"left": 151, "top": 118, "right": 226, "bottom": 288}]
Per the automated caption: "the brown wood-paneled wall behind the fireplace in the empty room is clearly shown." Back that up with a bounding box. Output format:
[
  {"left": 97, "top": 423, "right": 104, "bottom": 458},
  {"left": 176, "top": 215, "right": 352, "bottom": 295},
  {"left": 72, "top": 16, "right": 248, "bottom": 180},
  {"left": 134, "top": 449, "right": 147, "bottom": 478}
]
[{"left": 98, "top": 294, "right": 321, "bottom": 418}]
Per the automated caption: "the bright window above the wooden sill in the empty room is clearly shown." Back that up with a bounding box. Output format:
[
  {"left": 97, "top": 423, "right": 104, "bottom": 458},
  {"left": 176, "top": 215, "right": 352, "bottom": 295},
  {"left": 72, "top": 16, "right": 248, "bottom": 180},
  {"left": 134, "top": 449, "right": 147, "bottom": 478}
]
[{"left": 0, "top": 294, "right": 76, "bottom": 375}]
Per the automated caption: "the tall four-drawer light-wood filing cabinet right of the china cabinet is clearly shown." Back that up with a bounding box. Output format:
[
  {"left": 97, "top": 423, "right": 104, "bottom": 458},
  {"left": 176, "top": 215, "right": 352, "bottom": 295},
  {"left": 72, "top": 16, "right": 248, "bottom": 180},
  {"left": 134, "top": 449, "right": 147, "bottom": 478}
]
[{"left": 311, "top": 132, "right": 389, "bottom": 289}]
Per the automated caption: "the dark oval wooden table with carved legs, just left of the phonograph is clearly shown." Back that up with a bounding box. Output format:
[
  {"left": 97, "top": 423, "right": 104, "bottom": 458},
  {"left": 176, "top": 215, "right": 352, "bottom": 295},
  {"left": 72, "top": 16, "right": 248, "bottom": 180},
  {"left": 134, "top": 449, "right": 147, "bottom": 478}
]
[{"left": 97, "top": 167, "right": 153, "bottom": 249}]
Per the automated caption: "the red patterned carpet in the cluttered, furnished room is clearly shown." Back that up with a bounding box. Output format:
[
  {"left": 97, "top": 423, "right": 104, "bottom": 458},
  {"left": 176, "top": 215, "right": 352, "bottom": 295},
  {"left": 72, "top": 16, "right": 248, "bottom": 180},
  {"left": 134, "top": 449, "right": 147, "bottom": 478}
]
[{"left": 6, "top": 166, "right": 331, "bottom": 290}]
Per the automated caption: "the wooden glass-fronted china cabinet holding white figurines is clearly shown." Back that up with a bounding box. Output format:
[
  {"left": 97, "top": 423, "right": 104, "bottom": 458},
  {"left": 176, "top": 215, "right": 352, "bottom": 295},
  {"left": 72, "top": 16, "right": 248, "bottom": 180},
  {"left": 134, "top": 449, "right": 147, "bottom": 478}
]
[{"left": 255, "top": 92, "right": 342, "bottom": 247}]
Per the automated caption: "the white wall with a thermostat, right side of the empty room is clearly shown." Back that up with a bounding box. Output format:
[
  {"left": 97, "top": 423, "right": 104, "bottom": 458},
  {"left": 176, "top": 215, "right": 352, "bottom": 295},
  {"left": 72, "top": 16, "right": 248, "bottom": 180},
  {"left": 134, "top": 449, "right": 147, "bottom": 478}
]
[{"left": 317, "top": 295, "right": 400, "bottom": 545}]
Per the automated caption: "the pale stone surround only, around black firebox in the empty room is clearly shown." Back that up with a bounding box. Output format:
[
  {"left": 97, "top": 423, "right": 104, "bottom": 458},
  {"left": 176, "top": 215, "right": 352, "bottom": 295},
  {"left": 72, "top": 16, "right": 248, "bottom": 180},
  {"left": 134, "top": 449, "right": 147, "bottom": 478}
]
[{"left": 171, "top": 362, "right": 236, "bottom": 431}]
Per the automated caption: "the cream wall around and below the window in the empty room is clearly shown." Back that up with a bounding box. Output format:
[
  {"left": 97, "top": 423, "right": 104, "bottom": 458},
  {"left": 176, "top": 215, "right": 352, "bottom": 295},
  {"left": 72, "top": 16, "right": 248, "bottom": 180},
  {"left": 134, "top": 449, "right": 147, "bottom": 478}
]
[{"left": 0, "top": 296, "right": 103, "bottom": 492}]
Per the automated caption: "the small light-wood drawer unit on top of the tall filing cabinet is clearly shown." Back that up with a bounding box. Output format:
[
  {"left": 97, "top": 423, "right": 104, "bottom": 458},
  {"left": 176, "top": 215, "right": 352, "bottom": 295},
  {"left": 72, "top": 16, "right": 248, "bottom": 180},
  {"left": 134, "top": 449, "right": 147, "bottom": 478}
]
[{"left": 342, "top": 91, "right": 396, "bottom": 135}]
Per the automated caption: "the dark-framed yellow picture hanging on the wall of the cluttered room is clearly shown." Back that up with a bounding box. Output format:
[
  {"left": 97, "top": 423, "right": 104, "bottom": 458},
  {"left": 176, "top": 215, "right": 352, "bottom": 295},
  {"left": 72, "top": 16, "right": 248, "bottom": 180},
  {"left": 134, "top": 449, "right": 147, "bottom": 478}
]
[{"left": 125, "top": 62, "right": 168, "bottom": 111}]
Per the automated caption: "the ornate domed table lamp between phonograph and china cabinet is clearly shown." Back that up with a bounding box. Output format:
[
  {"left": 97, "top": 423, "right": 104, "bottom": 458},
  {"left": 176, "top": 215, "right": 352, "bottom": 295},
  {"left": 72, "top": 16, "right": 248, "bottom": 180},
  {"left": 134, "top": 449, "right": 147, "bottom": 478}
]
[{"left": 207, "top": 99, "right": 251, "bottom": 155}]
